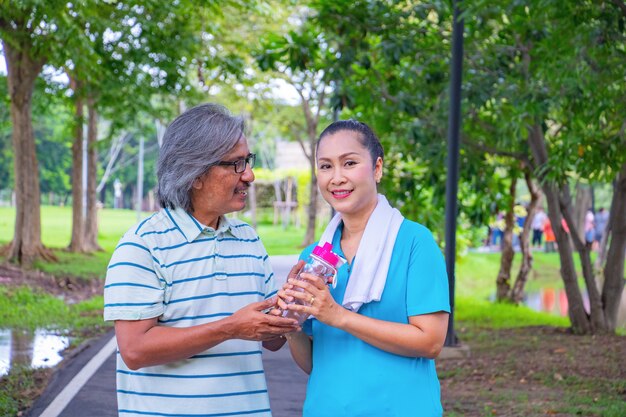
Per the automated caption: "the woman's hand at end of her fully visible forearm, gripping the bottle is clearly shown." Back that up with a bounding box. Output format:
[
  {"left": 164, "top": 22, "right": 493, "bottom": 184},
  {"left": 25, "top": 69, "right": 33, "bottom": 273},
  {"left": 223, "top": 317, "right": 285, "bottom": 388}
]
[{"left": 284, "top": 273, "right": 347, "bottom": 327}]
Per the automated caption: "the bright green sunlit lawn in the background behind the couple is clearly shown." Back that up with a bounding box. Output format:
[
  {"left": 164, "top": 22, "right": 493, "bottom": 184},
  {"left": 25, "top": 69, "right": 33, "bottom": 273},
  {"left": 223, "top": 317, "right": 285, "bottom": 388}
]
[{"left": 0, "top": 206, "right": 562, "bottom": 288}]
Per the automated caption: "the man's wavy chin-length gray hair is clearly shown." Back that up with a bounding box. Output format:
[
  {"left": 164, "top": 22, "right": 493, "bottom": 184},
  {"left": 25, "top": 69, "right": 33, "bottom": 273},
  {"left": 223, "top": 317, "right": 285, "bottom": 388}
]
[{"left": 157, "top": 104, "right": 244, "bottom": 212}]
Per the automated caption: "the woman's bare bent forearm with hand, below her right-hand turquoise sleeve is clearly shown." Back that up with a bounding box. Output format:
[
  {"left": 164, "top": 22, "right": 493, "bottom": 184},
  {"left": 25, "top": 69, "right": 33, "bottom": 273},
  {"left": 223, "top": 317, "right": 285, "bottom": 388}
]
[{"left": 286, "top": 274, "right": 448, "bottom": 359}]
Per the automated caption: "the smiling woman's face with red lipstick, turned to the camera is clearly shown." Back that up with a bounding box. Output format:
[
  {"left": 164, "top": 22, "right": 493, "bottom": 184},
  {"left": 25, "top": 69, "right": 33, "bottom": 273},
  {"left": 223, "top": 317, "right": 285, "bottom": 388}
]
[{"left": 317, "top": 130, "right": 383, "bottom": 215}]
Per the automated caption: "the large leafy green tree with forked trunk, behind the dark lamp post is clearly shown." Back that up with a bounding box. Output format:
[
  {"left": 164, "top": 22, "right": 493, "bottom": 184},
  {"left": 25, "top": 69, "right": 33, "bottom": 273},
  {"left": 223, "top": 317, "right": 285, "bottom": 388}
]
[{"left": 286, "top": 0, "right": 626, "bottom": 333}]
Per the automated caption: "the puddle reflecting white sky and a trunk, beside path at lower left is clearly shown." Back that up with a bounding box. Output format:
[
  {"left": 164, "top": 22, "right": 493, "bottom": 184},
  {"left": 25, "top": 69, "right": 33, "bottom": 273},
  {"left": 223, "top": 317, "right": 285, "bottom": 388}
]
[{"left": 0, "top": 329, "right": 70, "bottom": 376}]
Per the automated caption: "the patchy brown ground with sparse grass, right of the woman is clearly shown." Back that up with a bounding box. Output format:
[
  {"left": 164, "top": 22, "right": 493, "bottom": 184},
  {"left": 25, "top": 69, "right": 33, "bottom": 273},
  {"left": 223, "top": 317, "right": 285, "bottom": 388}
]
[{"left": 437, "top": 327, "right": 626, "bottom": 417}]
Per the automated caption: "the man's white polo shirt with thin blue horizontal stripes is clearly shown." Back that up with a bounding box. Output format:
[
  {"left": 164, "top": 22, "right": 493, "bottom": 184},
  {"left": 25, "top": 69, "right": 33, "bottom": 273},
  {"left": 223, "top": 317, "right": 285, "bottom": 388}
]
[{"left": 104, "top": 209, "right": 276, "bottom": 417}]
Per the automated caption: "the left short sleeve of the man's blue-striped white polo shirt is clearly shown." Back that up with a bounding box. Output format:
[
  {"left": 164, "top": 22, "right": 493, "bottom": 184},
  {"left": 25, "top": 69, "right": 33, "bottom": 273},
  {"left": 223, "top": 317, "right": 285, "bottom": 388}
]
[{"left": 104, "top": 231, "right": 167, "bottom": 320}]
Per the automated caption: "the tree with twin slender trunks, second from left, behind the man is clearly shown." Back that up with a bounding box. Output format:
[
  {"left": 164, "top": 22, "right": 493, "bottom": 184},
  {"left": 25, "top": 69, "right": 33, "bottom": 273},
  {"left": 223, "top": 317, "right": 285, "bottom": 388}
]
[{"left": 66, "top": 0, "right": 210, "bottom": 251}]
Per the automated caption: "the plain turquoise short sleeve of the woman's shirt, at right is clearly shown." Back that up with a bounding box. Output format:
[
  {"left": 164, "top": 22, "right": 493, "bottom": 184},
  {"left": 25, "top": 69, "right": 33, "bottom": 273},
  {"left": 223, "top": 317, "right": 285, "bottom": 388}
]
[{"left": 406, "top": 225, "right": 450, "bottom": 316}]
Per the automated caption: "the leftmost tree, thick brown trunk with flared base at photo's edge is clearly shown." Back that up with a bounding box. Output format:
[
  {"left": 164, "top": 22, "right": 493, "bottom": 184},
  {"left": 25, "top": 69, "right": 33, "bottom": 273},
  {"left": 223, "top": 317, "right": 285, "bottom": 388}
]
[{"left": 0, "top": 1, "right": 66, "bottom": 265}]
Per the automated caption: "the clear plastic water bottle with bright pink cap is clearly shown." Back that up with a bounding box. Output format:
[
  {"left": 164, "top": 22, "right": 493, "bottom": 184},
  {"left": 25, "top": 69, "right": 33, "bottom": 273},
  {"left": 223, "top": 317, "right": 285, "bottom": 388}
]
[{"left": 283, "top": 242, "right": 343, "bottom": 324}]
